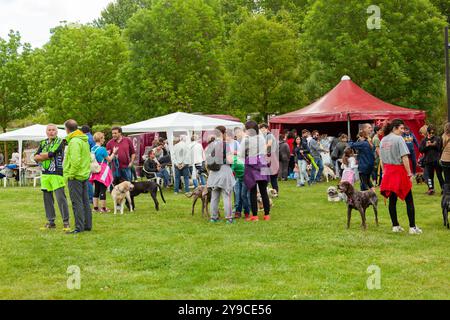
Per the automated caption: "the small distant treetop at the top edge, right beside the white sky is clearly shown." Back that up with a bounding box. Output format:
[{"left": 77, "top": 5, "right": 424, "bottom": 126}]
[{"left": 94, "top": 0, "right": 152, "bottom": 29}]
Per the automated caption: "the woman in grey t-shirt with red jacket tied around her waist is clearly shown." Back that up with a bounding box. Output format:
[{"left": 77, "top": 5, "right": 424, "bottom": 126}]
[{"left": 380, "top": 119, "right": 422, "bottom": 234}]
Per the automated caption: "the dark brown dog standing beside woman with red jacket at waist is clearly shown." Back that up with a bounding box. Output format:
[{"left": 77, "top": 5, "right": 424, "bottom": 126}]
[{"left": 338, "top": 181, "right": 378, "bottom": 229}]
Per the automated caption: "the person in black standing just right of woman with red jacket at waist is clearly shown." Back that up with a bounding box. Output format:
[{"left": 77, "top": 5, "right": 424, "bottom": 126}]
[{"left": 419, "top": 126, "right": 444, "bottom": 195}]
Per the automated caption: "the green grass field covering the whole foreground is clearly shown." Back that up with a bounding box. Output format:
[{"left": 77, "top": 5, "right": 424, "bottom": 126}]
[{"left": 0, "top": 181, "right": 450, "bottom": 299}]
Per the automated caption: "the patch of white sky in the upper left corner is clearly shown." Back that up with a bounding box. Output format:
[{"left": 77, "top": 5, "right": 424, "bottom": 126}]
[{"left": 0, "top": 0, "right": 112, "bottom": 48}]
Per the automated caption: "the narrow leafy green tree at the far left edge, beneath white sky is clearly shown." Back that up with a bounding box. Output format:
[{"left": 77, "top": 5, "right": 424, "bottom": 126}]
[{"left": 0, "top": 30, "right": 34, "bottom": 159}]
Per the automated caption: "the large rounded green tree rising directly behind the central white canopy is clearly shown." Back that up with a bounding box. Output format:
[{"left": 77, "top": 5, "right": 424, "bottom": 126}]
[{"left": 121, "top": 0, "right": 223, "bottom": 117}]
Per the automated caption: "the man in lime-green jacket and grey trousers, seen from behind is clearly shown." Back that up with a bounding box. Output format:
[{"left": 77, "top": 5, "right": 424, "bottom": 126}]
[{"left": 64, "top": 120, "right": 92, "bottom": 234}]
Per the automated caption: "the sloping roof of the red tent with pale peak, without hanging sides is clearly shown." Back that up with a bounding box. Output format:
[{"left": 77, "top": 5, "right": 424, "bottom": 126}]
[{"left": 270, "top": 76, "right": 425, "bottom": 124}]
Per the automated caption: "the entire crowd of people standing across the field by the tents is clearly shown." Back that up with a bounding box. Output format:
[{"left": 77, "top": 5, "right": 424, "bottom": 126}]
[{"left": 0, "top": 116, "right": 450, "bottom": 233}]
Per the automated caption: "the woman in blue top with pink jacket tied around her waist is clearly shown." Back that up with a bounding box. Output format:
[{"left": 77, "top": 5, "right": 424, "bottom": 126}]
[{"left": 89, "top": 132, "right": 117, "bottom": 213}]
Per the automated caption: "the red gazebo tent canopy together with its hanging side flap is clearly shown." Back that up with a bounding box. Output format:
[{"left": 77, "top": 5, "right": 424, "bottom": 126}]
[{"left": 270, "top": 76, "right": 426, "bottom": 139}]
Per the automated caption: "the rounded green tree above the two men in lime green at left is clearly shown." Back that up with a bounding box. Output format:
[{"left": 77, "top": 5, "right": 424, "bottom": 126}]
[{"left": 41, "top": 25, "right": 127, "bottom": 126}]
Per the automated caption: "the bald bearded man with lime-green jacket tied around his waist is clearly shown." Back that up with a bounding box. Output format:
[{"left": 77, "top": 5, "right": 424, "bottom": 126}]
[{"left": 34, "top": 124, "right": 70, "bottom": 231}]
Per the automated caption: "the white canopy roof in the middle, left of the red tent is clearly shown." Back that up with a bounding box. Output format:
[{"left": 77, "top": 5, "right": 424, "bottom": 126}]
[{"left": 122, "top": 112, "right": 244, "bottom": 133}]
